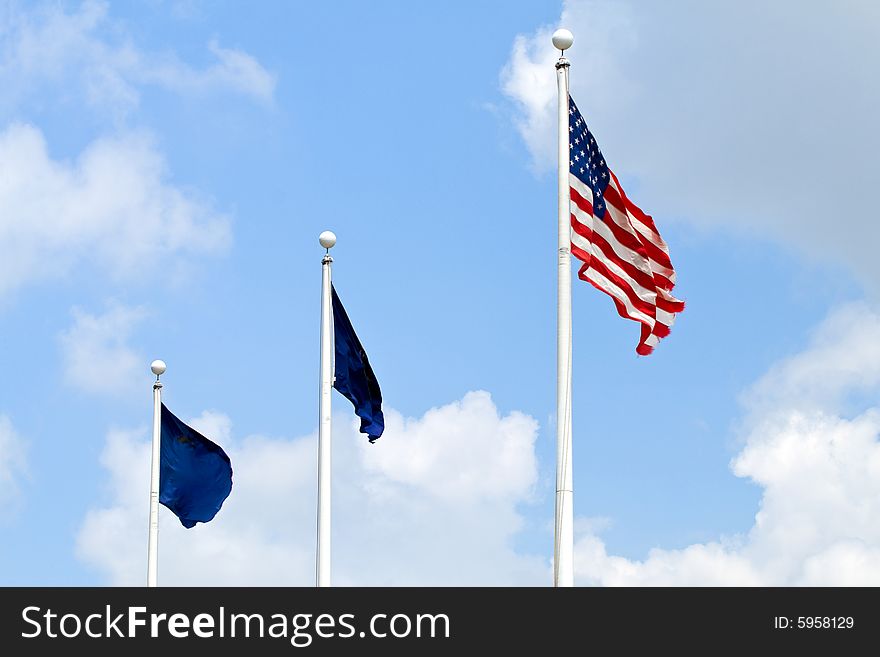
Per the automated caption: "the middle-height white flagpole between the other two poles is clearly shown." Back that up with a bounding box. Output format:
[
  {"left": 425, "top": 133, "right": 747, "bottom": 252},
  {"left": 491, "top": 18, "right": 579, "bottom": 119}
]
[{"left": 315, "top": 230, "right": 336, "bottom": 586}]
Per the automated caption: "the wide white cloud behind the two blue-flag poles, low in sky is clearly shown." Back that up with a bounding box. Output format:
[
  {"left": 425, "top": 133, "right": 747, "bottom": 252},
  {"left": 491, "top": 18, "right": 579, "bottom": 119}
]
[{"left": 77, "top": 392, "right": 549, "bottom": 586}]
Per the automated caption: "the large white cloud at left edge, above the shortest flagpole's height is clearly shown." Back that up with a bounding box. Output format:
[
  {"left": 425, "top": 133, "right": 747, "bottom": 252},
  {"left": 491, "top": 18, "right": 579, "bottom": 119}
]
[{"left": 0, "top": 124, "right": 231, "bottom": 295}]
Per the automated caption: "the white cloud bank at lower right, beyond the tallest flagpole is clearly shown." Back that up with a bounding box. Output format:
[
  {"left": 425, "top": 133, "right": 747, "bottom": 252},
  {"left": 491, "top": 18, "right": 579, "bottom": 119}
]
[{"left": 576, "top": 303, "right": 880, "bottom": 586}]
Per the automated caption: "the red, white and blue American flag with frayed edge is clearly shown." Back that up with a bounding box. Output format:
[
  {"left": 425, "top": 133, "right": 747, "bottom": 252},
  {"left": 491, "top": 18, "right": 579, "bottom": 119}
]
[{"left": 568, "top": 96, "right": 684, "bottom": 356}]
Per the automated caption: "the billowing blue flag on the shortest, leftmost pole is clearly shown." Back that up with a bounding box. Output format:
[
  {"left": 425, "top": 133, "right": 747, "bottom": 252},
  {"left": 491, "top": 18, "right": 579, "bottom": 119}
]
[{"left": 159, "top": 404, "right": 232, "bottom": 529}]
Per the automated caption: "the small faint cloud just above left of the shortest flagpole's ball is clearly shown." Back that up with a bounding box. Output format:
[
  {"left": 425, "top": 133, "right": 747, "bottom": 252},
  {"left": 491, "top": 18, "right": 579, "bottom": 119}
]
[{"left": 60, "top": 304, "right": 146, "bottom": 394}]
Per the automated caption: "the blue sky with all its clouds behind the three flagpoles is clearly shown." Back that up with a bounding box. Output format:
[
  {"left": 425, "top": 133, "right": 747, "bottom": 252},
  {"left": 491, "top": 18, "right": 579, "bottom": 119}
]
[{"left": 0, "top": 0, "right": 880, "bottom": 586}]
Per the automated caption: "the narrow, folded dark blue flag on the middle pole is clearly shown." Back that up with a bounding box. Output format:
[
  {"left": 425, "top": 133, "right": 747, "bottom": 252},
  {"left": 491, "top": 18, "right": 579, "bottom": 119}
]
[{"left": 331, "top": 286, "right": 385, "bottom": 443}]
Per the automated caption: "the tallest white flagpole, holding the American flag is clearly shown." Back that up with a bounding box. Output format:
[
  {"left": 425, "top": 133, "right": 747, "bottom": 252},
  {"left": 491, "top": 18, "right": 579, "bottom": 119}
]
[{"left": 553, "top": 29, "right": 574, "bottom": 587}]
